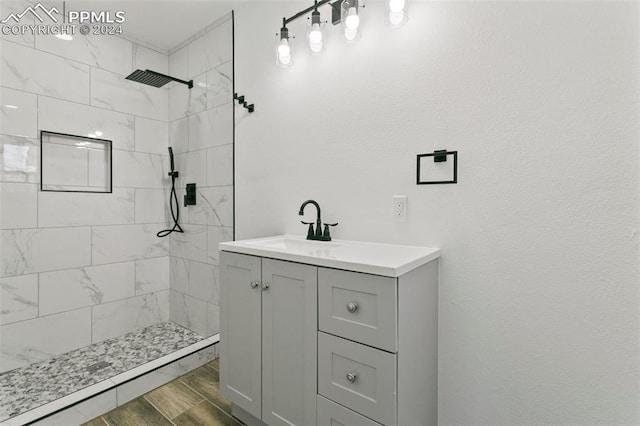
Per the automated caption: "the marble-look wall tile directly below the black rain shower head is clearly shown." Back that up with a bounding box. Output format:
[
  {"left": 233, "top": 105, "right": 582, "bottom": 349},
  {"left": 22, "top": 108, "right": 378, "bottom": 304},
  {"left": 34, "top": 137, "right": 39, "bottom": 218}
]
[{"left": 91, "top": 68, "right": 170, "bottom": 121}]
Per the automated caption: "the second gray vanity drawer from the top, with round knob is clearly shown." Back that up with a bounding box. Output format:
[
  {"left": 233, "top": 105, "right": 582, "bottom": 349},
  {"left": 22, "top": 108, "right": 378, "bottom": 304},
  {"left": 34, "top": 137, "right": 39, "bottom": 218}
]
[{"left": 318, "top": 332, "right": 397, "bottom": 426}]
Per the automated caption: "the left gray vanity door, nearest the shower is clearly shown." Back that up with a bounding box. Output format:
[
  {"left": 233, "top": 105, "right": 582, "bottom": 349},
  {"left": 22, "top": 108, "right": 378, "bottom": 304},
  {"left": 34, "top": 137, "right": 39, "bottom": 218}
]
[{"left": 220, "top": 251, "right": 262, "bottom": 418}]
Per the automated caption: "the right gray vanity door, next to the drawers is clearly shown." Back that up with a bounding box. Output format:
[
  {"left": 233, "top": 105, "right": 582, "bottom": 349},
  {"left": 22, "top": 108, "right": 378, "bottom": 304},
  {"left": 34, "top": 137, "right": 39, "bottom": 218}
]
[{"left": 262, "top": 259, "right": 318, "bottom": 426}]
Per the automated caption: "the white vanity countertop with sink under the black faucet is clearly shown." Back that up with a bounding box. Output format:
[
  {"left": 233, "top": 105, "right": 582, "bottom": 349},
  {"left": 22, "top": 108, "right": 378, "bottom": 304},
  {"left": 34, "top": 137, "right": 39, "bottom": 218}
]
[{"left": 218, "top": 235, "right": 440, "bottom": 277}]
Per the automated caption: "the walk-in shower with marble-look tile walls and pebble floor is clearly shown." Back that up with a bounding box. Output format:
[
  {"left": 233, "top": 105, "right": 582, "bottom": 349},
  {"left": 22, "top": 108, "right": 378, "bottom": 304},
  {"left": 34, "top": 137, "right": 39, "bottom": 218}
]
[{"left": 0, "top": 7, "right": 234, "bottom": 426}]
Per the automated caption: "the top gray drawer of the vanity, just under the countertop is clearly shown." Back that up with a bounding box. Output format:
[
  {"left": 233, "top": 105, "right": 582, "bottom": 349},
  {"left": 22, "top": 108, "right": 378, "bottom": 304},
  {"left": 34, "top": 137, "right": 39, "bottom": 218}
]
[{"left": 318, "top": 268, "right": 397, "bottom": 352}]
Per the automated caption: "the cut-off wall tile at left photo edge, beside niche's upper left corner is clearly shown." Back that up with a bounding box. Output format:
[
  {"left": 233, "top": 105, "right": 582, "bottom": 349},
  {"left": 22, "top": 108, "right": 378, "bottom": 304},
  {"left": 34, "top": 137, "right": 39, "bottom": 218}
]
[{"left": 0, "top": 87, "right": 38, "bottom": 138}]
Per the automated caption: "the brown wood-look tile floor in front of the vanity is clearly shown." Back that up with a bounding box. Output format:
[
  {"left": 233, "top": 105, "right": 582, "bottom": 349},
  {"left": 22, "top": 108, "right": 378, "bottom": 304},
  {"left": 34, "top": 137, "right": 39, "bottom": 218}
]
[{"left": 83, "top": 359, "right": 242, "bottom": 426}]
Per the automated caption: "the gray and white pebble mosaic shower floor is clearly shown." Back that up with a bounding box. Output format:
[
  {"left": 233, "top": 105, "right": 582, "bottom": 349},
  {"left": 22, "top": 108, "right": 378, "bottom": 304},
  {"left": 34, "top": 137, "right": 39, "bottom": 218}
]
[{"left": 0, "top": 322, "right": 204, "bottom": 422}]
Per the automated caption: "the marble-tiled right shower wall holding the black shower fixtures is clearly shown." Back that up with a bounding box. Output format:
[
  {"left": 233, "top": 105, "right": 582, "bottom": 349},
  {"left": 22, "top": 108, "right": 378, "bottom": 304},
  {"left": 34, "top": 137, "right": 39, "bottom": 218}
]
[{"left": 169, "top": 15, "right": 233, "bottom": 336}]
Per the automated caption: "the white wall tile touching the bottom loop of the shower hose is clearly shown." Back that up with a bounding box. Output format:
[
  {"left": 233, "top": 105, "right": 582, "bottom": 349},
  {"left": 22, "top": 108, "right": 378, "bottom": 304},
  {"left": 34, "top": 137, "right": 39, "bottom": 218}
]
[{"left": 92, "top": 224, "right": 169, "bottom": 265}]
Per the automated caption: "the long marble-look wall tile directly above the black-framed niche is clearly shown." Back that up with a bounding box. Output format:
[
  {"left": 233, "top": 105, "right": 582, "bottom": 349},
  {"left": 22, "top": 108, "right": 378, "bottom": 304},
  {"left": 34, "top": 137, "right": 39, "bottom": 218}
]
[{"left": 38, "top": 96, "right": 134, "bottom": 151}]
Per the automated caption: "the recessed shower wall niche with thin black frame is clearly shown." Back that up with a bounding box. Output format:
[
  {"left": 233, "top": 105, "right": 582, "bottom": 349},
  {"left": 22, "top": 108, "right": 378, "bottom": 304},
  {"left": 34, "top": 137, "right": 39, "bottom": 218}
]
[{"left": 40, "top": 130, "right": 112, "bottom": 193}]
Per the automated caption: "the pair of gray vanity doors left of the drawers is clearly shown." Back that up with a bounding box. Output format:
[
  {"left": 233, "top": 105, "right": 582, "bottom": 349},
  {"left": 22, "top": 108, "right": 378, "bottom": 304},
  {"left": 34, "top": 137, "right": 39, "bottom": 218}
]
[{"left": 220, "top": 251, "right": 318, "bottom": 426}]
